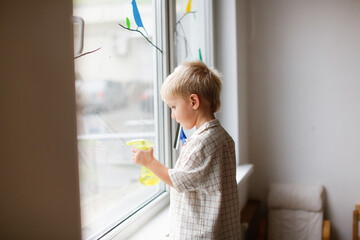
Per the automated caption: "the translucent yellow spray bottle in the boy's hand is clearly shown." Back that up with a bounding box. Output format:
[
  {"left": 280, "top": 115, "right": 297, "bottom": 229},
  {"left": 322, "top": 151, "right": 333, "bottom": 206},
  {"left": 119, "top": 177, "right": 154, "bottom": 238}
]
[{"left": 126, "top": 139, "right": 160, "bottom": 186}]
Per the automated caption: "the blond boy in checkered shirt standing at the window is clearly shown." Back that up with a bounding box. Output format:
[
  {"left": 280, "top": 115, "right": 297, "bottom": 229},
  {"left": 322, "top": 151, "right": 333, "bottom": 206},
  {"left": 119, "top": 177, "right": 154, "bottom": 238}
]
[{"left": 132, "top": 62, "right": 241, "bottom": 240}]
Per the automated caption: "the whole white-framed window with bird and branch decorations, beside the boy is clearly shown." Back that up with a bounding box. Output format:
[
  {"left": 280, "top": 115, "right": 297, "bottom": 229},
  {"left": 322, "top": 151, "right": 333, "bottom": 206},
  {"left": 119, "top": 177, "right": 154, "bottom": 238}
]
[{"left": 73, "top": 0, "right": 213, "bottom": 239}]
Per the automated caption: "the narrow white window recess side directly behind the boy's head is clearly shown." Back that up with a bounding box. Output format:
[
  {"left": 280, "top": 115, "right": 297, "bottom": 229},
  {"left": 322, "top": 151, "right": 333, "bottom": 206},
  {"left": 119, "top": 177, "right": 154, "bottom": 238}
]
[{"left": 214, "top": 0, "right": 239, "bottom": 161}]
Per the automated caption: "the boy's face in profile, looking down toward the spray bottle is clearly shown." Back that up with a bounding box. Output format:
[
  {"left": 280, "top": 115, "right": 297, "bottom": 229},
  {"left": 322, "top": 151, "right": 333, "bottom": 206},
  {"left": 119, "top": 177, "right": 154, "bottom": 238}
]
[{"left": 166, "top": 97, "right": 196, "bottom": 129}]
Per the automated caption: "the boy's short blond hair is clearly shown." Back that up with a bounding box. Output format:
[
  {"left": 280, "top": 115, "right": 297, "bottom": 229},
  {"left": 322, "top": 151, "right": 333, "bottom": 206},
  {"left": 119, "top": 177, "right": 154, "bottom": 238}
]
[{"left": 161, "top": 61, "right": 222, "bottom": 113}]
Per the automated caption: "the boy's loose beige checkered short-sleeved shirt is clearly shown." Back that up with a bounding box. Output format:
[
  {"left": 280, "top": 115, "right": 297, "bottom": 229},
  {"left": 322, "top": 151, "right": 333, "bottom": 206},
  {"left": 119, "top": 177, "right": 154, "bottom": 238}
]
[{"left": 169, "top": 119, "right": 241, "bottom": 240}]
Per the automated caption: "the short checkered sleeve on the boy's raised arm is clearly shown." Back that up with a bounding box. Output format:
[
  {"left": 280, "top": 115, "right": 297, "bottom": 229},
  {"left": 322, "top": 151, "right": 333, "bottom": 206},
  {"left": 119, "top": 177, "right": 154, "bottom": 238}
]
[{"left": 169, "top": 143, "right": 219, "bottom": 192}]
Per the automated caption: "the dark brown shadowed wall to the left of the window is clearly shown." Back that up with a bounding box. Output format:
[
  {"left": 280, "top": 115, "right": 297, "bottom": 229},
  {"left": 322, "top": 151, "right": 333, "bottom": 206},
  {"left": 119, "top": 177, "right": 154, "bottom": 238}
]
[{"left": 0, "top": 0, "right": 81, "bottom": 239}]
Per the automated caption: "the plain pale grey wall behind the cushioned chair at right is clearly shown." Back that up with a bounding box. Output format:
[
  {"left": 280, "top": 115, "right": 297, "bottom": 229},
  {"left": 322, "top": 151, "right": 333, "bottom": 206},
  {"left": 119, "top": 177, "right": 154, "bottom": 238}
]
[{"left": 249, "top": 0, "right": 360, "bottom": 239}]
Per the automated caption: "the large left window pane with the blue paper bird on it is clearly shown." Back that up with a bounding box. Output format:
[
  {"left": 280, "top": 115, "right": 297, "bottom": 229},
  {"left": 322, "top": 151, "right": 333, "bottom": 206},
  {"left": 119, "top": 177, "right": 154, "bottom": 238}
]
[{"left": 73, "top": 0, "right": 165, "bottom": 239}]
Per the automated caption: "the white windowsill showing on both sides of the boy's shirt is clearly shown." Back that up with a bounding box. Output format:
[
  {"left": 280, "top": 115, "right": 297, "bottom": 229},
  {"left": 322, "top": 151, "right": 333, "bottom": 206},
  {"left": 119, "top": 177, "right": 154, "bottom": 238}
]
[{"left": 128, "top": 164, "right": 254, "bottom": 240}]
